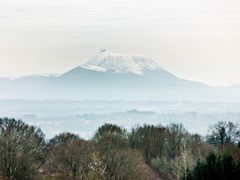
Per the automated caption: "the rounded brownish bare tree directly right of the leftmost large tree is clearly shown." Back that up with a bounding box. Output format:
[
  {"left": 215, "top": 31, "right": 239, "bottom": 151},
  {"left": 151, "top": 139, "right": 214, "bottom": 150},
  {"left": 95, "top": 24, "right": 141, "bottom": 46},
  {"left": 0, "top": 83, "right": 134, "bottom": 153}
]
[{"left": 45, "top": 133, "right": 94, "bottom": 180}]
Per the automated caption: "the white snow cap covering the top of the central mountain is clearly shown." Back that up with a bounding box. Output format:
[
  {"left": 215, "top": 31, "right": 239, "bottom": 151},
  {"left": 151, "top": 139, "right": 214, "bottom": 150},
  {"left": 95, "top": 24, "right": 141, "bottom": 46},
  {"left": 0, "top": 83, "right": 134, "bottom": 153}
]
[{"left": 80, "top": 50, "right": 162, "bottom": 74}]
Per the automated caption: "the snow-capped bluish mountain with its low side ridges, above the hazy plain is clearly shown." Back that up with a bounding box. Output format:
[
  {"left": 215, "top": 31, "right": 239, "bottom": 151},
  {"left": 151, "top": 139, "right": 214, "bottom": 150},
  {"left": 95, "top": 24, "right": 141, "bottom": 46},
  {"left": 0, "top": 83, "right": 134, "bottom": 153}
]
[{"left": 0, "top": 50, "right": 240, "bottom": 101}]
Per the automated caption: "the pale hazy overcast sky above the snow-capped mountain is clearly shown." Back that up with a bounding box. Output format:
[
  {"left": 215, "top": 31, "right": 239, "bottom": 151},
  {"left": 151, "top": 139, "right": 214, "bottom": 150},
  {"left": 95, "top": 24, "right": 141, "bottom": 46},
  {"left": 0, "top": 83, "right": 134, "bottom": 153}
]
[{"left": 0, "top": 0, "right": 240, "bottom": 85}]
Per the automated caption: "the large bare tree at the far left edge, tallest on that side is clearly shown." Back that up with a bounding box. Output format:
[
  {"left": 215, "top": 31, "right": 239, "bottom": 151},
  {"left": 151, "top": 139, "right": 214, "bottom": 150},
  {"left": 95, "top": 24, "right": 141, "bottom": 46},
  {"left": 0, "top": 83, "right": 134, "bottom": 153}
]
[{"left": 0, "top": 118, "right": 45, "bottom": 180}]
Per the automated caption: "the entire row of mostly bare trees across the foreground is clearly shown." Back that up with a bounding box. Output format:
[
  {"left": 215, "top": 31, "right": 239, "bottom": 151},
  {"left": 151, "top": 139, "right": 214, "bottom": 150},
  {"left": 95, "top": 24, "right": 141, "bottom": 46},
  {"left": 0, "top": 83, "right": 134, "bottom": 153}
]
[{"left": 0, "top": 118, "right": 240, "bottom": 180}]
